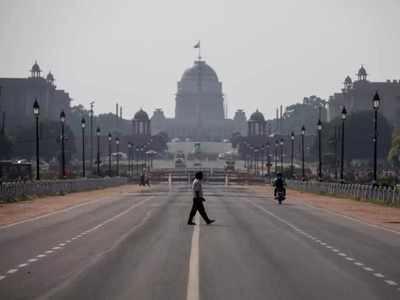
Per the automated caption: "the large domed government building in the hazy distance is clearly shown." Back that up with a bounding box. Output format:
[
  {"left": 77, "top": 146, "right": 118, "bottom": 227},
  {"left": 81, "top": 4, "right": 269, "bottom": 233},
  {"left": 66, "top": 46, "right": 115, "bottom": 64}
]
[{"left": 151, "top": 58, "right": 247, "bottom": 141}]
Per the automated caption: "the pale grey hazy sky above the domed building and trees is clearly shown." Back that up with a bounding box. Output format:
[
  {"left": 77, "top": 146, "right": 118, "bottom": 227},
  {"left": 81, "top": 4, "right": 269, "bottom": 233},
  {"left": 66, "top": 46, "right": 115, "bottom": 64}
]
[{"left": 0, "top": 0, "right": 400, "bottom": 118}]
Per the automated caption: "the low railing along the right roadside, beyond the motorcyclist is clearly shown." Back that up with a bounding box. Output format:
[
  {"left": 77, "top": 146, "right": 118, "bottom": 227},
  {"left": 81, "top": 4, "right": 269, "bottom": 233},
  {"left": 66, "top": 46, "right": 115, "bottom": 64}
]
[{"left": 287, "top": 180, "right": 400, "bottom": 206}]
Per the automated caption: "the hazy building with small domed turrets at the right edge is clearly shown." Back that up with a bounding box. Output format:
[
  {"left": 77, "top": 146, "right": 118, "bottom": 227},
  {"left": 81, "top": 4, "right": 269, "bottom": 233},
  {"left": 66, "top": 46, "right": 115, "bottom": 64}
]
[{"left": 328, "top": 66, "right": 400, "bottom": 128}]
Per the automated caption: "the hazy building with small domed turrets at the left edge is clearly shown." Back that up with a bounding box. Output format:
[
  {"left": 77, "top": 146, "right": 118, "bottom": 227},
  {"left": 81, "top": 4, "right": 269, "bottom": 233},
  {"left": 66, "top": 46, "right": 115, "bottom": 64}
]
[{"left": 0, "top": 62, "right": 72, "bottom": 130}]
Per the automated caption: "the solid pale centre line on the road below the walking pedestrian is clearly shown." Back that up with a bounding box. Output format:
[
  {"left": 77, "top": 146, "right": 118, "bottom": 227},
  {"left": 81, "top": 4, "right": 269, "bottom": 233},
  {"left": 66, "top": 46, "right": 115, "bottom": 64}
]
[{"left": 186, "top": 215, "right": 200, "bottom": 300}]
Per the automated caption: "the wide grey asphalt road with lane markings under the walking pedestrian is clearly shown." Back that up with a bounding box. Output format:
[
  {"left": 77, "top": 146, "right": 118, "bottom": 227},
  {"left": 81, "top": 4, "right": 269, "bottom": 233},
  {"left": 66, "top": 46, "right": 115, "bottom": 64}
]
[{"left": 0, "top": 185, "right": 400, "bottom": 300}]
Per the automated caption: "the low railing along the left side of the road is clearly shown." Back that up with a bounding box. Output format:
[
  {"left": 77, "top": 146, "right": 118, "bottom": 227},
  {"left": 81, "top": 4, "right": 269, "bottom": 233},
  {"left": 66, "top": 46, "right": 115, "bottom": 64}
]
[{"left": 0, "top": 177, "right": 128, "bottom": 201}]
